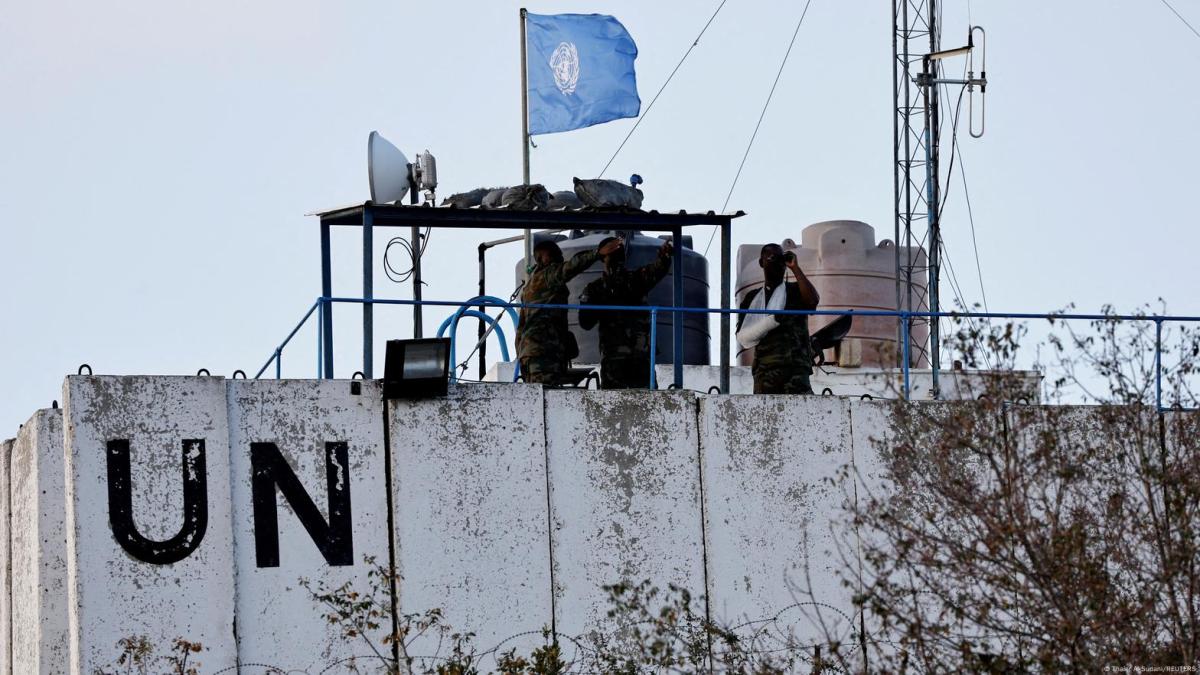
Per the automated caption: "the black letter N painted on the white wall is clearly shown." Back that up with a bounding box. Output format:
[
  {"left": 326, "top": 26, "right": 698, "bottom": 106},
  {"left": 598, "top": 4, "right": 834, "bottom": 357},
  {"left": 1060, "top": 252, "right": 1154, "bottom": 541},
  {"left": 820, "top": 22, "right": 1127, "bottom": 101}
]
[{"left": 250, "top": 442, "right": 354, "bottom": 567}]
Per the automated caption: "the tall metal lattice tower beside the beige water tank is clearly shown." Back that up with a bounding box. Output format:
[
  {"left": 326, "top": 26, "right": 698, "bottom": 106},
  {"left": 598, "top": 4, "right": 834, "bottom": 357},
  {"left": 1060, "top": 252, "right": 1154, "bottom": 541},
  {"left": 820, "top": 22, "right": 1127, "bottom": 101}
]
[{"left": 892, "top": 0, "right": 940, "bottom": 390}]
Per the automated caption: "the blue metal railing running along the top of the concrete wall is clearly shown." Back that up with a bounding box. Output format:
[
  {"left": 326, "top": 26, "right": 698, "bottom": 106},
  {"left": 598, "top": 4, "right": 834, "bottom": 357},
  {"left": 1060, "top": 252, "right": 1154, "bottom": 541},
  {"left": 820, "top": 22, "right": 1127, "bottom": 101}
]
[{"left": 254, "top": 297, "right": 1200, "bottom": 411}]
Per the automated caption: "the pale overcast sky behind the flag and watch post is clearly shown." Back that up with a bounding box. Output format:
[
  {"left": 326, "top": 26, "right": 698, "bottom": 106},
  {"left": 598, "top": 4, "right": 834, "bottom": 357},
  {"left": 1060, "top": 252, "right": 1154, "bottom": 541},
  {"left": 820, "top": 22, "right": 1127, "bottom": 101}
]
[{"left": 0, "top": 0, "right": 1200, "bottom": 427}]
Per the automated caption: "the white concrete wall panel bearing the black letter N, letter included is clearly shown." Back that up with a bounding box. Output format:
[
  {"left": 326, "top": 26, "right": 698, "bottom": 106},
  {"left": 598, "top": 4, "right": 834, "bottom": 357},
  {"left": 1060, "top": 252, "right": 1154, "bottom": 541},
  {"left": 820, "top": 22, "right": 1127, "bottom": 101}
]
[{"left": 226, "top": 380, "right": 391, "bottom": 674}]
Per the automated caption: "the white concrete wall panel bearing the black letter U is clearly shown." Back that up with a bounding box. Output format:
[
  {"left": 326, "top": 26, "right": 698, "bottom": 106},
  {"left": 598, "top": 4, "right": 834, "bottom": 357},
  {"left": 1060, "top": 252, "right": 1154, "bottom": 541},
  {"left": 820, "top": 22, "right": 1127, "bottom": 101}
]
[{"left": 66, "top": 376, "right": 238, "bottom": 673}]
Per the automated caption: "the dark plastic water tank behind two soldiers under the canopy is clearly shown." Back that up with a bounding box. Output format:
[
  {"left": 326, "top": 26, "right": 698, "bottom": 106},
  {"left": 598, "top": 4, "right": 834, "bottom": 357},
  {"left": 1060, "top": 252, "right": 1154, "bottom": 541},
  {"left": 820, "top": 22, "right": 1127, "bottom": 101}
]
[{"left": 516, "top": 231, "right": 709, "bottom": 365}]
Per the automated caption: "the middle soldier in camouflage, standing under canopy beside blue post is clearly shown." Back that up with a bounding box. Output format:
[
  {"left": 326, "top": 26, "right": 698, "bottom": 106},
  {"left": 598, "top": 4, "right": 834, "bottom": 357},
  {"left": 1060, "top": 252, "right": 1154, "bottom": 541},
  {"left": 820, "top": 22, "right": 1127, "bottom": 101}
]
[{"left": 580, "top": 237, "right": 671, "bottom": 389}]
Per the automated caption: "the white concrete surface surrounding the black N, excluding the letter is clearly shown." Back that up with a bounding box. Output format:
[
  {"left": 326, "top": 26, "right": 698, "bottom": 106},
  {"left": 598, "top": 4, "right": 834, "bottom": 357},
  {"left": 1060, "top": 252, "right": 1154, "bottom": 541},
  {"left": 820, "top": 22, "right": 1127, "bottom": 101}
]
[{"left": 226, "top": 380, "right": 391, "bottom": 673}]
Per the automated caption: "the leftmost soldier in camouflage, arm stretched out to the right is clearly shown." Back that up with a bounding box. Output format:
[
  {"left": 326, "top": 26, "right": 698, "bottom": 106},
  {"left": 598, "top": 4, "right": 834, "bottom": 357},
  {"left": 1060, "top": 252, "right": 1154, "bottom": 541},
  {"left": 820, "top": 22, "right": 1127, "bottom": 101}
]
[{"left": 517, "top": 241, "right": 620, "bottom": 384}]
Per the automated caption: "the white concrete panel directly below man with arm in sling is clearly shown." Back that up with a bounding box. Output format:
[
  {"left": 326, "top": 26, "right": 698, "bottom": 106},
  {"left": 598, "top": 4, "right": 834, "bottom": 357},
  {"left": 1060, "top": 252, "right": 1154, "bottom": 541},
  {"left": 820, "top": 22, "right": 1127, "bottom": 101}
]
[{"left": 700, "top": 396, "right": 854, "bottom": 650}]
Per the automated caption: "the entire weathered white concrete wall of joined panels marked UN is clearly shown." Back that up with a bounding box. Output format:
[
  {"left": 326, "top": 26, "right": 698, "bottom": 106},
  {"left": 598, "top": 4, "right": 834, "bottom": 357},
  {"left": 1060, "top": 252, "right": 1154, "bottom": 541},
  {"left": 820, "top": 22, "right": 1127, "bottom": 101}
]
[{"left": 0, "top": 376, "right": 1108, "bottom": 675}]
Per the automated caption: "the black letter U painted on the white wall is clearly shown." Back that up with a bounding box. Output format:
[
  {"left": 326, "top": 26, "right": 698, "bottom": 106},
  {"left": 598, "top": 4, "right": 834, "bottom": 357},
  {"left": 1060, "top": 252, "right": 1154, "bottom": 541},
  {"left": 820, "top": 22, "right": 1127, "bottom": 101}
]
[{"left": 108, "top": 438, "right": 209, "bottom": 565}]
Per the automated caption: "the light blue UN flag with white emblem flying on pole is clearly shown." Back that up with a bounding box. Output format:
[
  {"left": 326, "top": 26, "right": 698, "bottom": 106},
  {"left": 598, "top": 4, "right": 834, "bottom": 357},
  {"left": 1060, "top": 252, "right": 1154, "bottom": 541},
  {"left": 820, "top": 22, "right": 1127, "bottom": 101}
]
[{"left": 526, "top": 14, "right": 642, "bottom": 135}]
